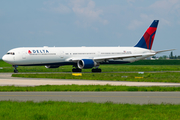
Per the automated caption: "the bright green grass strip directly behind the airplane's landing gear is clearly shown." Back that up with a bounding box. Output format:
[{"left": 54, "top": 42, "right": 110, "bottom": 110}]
[{"left": 0, "top": 65, "right": 180, "bottom": 73}]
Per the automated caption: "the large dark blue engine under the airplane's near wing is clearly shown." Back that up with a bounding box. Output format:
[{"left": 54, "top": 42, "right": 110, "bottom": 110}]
[{"left": 77, "top": 59, "right": 98, "bottom": 69}]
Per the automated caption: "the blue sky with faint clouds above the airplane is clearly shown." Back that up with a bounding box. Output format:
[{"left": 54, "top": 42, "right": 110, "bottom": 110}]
[{"left": 0, "top": 0, "right": 180, "bottom": 58}]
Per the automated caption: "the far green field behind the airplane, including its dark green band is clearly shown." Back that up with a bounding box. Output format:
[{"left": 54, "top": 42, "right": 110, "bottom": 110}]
[{"left": 0, "top": 60, "right": 180, "bottom": 72}]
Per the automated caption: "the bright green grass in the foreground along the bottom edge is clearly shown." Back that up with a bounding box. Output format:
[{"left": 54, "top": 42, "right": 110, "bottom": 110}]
[{"left": 0, "top": 101, "right": 180, "bottom": 120}]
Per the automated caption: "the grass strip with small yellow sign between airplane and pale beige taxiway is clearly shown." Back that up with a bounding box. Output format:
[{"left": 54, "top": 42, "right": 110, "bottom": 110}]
[{"left": 12, "top": 72, "right": 180, "bottom": 83}]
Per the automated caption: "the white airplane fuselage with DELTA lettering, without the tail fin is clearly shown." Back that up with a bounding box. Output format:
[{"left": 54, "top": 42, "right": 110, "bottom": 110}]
[{"left": 2, "top": 47, "right": 154, "bottom": 65}]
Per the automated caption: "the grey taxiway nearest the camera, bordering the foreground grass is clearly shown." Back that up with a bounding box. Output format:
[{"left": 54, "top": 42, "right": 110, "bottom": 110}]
[{"left": 0, "top": 92, "right": 180, "bottom": 104}]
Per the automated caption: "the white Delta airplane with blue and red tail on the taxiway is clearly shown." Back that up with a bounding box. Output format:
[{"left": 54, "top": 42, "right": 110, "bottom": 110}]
[{"left": 2, "top": 20, "right": 174, "bottom": 73}]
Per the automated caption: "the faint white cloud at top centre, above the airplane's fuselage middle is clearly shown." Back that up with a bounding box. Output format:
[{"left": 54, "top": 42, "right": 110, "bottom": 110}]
[{"left": 43, "top": 0, "right": 108, "bottom": 27}]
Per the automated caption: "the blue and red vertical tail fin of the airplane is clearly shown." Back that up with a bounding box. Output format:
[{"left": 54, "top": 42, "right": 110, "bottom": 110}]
[{"left": 134, "top": 20, "right": 159, "bottom": 50}]
